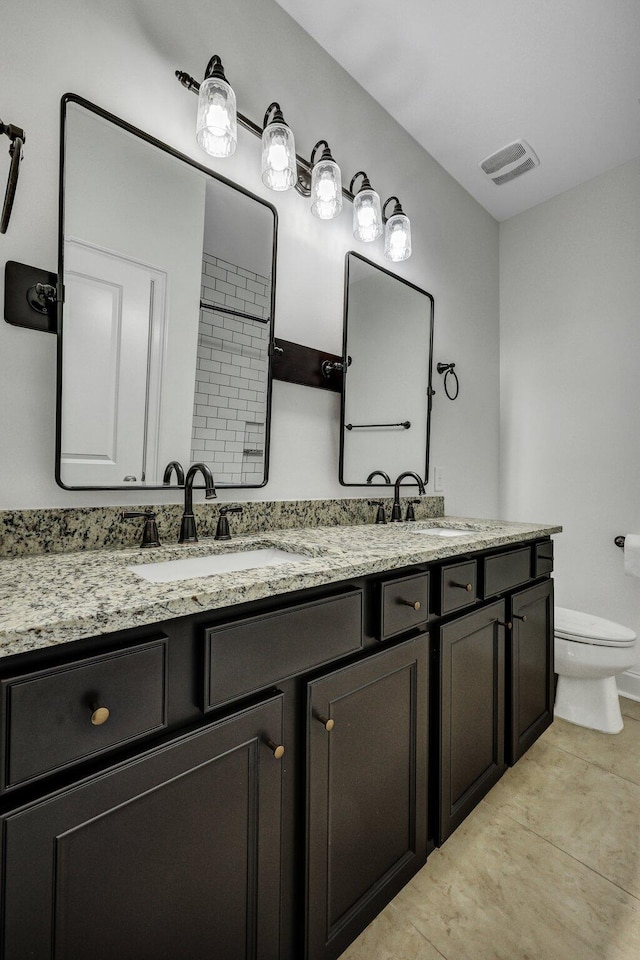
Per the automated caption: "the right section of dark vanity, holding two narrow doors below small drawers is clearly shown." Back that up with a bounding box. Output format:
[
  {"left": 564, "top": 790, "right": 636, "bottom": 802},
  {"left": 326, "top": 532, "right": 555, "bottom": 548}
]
[{"left": 430, "top": 540, "right": 554, "bottom": 845}]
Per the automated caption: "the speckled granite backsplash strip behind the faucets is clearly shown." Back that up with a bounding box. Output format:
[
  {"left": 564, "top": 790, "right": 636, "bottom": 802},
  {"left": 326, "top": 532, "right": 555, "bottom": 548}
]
[{"left": 0, "top": 496, "right": 444, "bottom": 557}]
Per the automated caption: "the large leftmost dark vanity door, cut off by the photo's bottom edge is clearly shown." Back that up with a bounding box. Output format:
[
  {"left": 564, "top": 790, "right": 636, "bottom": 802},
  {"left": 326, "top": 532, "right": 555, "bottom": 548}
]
[{"left": 1, "top": 696, "right": 282, "bottom": 960}]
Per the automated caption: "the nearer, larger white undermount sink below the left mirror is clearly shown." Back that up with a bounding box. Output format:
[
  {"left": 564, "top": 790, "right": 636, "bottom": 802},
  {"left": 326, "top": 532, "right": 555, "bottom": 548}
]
[{"left": 127, "top": 547, "right": 308, "bottom": 583}]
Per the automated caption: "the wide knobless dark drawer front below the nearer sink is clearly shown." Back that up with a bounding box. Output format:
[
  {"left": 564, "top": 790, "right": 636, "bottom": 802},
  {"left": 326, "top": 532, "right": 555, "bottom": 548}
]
[{"left": 203, "top": 590, "right": 362, "bottom": 710}]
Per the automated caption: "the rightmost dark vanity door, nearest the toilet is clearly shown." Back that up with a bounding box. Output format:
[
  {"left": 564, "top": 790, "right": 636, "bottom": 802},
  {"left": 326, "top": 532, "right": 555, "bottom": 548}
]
[{"left": 506, "top": 580, "right": 554, "bottom": 764}]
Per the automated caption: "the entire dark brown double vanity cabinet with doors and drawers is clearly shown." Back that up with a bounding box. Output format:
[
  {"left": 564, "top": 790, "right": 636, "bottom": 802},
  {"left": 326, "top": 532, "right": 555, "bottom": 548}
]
[{"left": 0, "top": 539, "right": 553, "bottom": 960}]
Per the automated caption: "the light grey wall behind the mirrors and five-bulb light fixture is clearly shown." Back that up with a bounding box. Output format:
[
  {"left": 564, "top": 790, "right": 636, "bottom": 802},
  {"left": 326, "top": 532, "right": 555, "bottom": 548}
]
[{"left": 0, "top": 0, "right": 500, "bottom": 519}]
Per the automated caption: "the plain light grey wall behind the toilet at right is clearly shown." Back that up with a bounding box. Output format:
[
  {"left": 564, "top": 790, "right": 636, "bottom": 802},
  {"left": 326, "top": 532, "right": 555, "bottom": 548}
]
[{"left": 500, "top": 160, "right": 640, "bottom": 696}]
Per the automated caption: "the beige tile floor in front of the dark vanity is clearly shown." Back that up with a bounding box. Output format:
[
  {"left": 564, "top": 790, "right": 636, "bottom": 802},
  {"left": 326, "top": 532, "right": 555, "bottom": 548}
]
[{"left": 341, "top": 700, "right": 640, "bottom": 960}]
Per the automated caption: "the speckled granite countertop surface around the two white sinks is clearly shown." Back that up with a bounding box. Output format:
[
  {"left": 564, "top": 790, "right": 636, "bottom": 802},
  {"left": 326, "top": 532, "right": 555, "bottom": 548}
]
[{"left": 0, "top": 517, "right": 562, "bottom": 657}]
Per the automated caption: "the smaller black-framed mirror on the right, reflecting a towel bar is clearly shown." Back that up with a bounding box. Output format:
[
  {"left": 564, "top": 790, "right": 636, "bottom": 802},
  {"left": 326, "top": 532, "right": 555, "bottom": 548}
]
[{"left": 340, "top": 252, "right": 433, "bottom": 486}]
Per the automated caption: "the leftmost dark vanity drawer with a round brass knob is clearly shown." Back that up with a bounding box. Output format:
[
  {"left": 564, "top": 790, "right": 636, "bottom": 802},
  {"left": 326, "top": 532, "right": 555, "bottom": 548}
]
[{"left": 0, "top": 637, "right": 167, "bottom": 788}]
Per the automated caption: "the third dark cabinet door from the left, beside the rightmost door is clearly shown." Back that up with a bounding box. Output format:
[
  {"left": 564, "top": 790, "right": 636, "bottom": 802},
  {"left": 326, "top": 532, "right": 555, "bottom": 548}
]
[{"left": 438, "top": 600, "right": 505, "bottom": 843}]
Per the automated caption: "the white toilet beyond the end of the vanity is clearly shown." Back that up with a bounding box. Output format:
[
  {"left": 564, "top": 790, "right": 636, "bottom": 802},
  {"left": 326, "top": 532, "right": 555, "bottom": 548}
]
[{"left": 554, "top": 607, "right": 638, "bottom": 733}]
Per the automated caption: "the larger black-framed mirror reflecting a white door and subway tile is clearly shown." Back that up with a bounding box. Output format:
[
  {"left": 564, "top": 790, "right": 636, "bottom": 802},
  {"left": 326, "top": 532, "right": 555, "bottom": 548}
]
[{"left": 56, "top": 94, "right": 277, "bottom": 489}]
